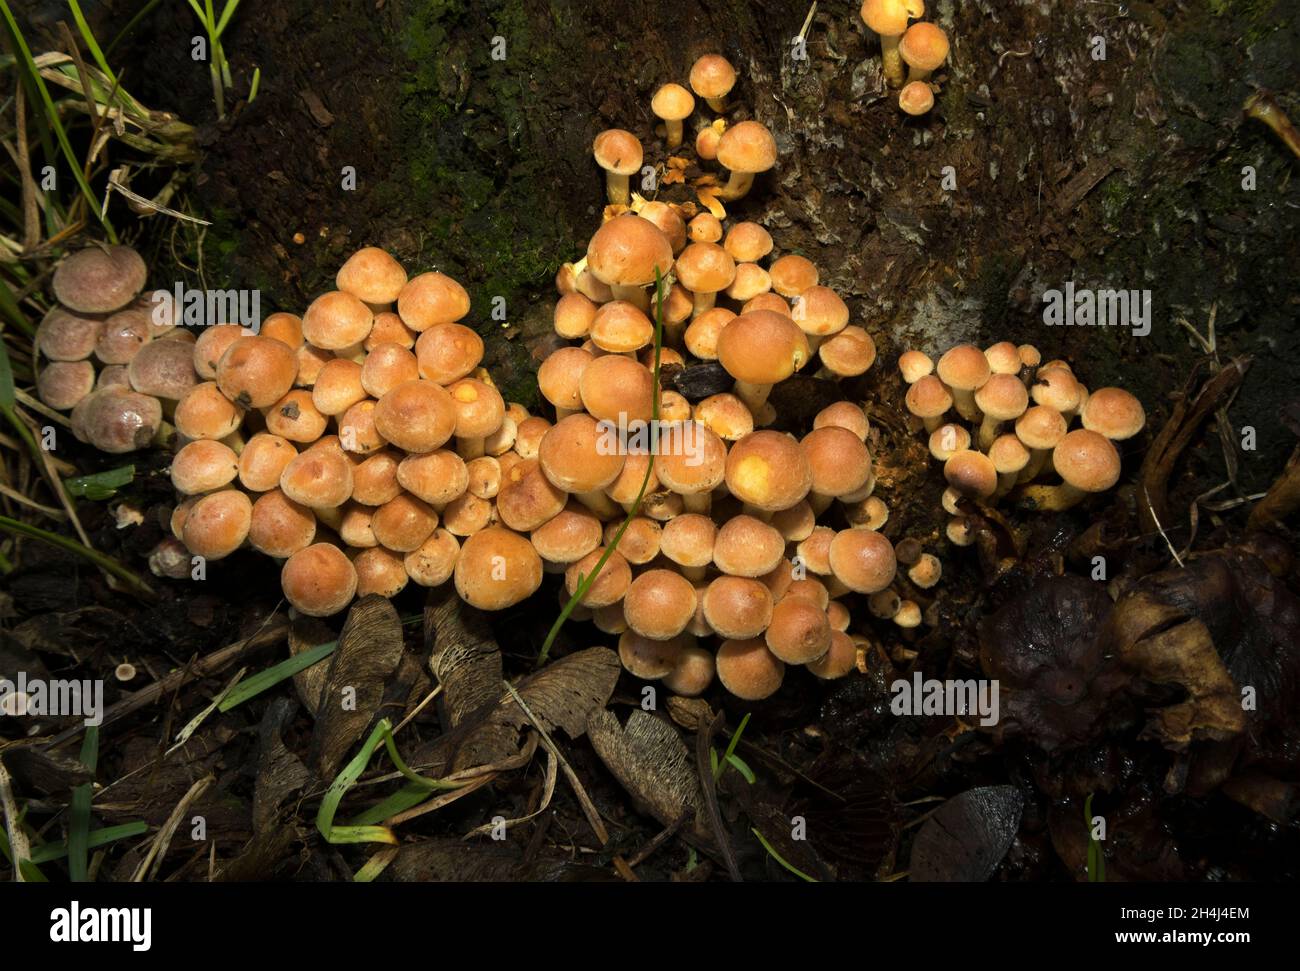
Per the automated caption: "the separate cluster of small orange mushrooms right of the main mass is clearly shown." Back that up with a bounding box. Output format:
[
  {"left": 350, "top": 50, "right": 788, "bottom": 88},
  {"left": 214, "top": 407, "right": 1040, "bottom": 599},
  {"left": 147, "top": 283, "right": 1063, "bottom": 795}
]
[{"left": 898, "top": 342, "right": 1147, "bottom": 546}]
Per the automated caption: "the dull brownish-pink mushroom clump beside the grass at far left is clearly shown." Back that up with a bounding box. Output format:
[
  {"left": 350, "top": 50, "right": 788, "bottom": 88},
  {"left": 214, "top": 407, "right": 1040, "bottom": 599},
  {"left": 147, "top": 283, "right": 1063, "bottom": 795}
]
[{"left": 36, "top": 244, "right": 198, "bottom": 454}]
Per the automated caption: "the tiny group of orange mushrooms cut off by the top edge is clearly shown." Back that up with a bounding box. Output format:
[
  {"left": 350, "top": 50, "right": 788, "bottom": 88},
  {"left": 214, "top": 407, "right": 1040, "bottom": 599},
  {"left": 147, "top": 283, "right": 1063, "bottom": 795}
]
[{"left": 859, "top": 0, "right": 949, "bottom": 116}]
